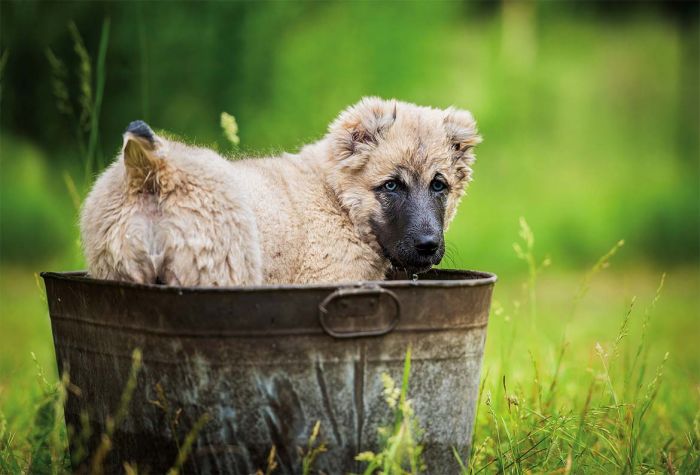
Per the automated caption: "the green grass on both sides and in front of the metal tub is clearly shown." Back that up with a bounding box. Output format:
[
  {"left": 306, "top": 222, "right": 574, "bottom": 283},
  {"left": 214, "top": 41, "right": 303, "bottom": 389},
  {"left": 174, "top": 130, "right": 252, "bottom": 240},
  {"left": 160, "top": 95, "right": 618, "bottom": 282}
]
[{"left": 0, "top": 234, "right": 700, "bottom": 473}]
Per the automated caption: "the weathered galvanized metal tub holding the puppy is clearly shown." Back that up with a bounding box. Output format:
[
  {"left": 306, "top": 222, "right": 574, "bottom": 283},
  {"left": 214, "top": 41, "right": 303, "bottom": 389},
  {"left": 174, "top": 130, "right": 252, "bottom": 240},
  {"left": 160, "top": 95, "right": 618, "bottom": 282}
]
[{"left": 42, "top": 270, "right": 496, "bottom": 474}]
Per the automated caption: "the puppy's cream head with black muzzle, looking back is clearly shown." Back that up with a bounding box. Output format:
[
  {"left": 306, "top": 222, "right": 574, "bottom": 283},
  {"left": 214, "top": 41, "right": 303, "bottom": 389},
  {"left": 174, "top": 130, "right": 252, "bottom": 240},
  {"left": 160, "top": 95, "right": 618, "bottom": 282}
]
[{"left": 328, "top": 97, "right": 481, "bottom": 273}]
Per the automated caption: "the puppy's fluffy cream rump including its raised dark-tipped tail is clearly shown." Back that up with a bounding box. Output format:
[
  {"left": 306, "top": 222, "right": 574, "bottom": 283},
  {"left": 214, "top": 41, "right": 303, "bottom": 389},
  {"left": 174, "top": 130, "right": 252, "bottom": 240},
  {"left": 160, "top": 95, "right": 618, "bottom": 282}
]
[{"left": 81, "top": 121, "right": 261, "bottom": 286}]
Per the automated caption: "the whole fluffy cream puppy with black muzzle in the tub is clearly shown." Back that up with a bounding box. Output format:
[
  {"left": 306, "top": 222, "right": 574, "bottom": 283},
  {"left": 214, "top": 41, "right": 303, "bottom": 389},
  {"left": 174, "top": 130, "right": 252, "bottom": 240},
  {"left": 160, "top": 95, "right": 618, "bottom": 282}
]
[{"left": 81, "top": 98, "right": 480, "bottom": 286}]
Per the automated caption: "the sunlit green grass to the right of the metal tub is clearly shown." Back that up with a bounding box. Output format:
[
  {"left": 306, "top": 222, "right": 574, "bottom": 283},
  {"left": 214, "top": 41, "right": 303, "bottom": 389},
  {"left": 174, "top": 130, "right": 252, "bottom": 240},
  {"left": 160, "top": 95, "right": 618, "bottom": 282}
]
[{"left": 468, "top": 228, "right": 700, "bottom": 473}]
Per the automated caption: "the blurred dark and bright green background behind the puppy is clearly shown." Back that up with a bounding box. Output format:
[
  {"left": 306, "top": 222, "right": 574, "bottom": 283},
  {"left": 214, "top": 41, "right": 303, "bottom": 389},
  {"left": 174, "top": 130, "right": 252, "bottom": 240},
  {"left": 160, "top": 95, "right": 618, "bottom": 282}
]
[{"left": 0, "top": 1, "right": 700, "bottom": 456}]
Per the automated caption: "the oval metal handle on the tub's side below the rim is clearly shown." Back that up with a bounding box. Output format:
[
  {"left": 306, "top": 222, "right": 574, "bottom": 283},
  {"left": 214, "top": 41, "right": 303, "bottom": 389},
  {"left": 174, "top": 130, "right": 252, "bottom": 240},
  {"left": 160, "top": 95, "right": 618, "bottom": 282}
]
[{"left": 318, "top": 286, "right": 401, "bottom": 338}]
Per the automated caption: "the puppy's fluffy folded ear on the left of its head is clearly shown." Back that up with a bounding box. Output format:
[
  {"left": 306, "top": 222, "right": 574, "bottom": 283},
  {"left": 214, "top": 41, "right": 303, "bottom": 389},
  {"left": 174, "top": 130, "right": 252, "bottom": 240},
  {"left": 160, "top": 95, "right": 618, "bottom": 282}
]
[{"left": 328, "top": 97, "right": 396, "bottom": 165}]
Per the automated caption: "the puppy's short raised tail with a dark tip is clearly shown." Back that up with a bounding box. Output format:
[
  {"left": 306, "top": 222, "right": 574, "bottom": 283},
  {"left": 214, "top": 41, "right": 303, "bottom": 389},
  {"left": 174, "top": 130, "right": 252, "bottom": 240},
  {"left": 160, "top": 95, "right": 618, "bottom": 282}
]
[{"left": 123, "top": 120, "right": 165, "bottom": 193}]
